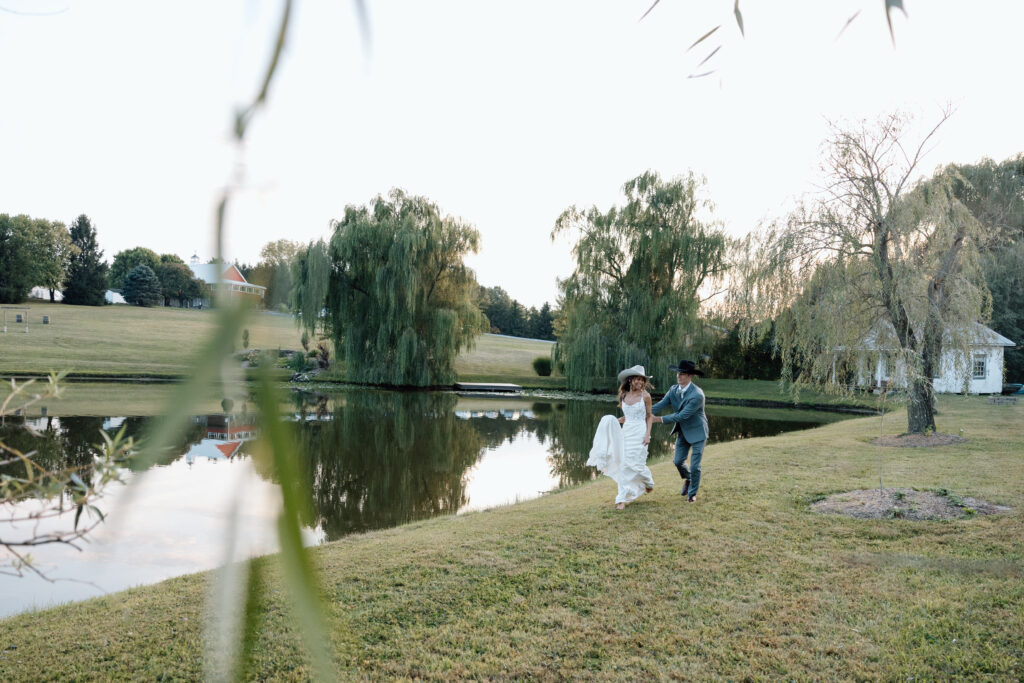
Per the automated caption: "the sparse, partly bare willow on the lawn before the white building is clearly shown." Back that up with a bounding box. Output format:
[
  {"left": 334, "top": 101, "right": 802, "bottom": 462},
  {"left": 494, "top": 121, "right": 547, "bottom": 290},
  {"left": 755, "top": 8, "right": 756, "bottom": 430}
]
[{"left": 733, "top": 115, "right": 990, "bottom": 433}]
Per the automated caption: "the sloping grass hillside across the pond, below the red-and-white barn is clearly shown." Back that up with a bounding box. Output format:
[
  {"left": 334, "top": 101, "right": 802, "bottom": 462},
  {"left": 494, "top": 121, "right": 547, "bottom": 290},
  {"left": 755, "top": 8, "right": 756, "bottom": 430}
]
[{"left": 0, "top": 302, "right": 301, "bottom": 377}]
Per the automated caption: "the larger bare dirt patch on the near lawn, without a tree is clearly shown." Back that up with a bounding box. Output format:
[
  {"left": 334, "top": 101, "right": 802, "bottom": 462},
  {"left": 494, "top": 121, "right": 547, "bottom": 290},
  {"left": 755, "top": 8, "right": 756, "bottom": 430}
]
[{"left": 811, "top": 488, "right": 1010, "bottom": 521}]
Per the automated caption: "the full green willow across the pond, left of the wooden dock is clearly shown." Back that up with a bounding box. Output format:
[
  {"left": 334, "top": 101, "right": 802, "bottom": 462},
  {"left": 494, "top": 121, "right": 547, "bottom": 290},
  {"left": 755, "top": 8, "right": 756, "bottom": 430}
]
[{"left": 295, "top": 189, "right": 481, "bottom": 386}]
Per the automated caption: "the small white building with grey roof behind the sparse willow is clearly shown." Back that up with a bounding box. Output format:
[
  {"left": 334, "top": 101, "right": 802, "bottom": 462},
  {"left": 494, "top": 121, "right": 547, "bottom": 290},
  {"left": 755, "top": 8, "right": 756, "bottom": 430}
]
[{"left": 857, "top": 323, "right": 1016, "bottom": 393}]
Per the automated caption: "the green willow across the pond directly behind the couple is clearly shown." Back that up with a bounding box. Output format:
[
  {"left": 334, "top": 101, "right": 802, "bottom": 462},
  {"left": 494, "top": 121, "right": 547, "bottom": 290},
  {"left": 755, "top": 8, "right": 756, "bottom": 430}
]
[{"left": 551, "top": 171, "right": 727, "bottom": 391}]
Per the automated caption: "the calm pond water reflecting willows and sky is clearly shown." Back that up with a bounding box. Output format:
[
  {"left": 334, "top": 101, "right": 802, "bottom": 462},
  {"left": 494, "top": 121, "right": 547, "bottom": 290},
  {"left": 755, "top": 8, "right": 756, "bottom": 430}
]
[{"left": 0, "top": 389, "right": 838, "bottom": 615}]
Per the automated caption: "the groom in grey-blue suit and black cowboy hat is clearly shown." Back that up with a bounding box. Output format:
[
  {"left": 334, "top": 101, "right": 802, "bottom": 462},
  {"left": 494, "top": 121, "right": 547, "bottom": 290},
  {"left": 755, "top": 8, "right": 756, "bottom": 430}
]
[{"left": 650, "top": 360, "right": 708, "bottom": 503}]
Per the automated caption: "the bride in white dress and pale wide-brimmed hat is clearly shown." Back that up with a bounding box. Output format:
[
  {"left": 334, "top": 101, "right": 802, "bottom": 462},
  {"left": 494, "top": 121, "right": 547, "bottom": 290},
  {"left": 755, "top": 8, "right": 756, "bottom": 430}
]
[{"left": 587, "top": 366, "right": 654, "bottom": 510}]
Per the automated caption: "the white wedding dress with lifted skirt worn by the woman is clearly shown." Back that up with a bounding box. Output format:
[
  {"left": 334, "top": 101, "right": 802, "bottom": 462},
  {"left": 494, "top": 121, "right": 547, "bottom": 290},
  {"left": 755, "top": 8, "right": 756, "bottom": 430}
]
[{"left": 587, "top": 399, "right": 654, "bottom": 503}]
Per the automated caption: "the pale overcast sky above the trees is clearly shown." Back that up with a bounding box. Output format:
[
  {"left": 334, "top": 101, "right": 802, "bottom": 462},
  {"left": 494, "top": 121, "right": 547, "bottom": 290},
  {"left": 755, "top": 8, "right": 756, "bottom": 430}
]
[{"left": 0, "top": 0, "right": 1024, "bottom": 307}]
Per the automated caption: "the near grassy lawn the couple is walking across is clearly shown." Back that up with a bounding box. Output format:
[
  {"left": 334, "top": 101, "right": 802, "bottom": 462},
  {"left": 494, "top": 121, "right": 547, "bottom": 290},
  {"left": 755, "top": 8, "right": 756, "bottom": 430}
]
[{"left": 0, "top": 396, "right": 1024, "bottom": 681}]
